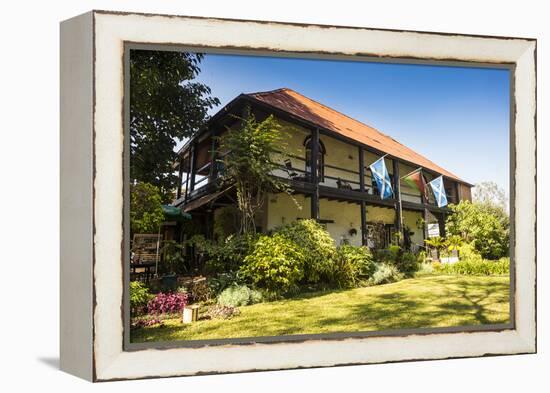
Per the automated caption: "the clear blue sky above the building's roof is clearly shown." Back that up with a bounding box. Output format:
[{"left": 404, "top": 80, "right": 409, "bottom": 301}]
[{"left": 198, "top": 54, "right": 510, "bottom": 195}]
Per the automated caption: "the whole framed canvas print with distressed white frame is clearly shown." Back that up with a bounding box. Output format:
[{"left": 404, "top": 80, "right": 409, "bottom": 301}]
[{"left": 61, "top": 11, "right": 536, "bottom": 381}]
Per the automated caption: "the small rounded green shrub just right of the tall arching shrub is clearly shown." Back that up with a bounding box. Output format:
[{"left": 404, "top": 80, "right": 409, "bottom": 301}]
[{"left": 332, "top": 245, "right": 376, "bottom": 288}]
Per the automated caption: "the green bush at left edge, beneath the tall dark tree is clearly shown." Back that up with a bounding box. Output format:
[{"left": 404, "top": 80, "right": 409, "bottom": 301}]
[{"left": 130, "top": 183, "right": 164, "bottom": 233}]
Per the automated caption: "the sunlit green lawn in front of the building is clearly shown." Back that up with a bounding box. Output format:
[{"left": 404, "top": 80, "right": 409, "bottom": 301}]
[{"left": 131, "top": 275, "right": 510, "bottom": 342}]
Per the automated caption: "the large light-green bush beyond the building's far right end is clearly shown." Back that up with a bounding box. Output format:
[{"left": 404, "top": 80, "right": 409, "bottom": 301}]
[{"left": 446, "top": 201, "right": 510, "bottom": 259}]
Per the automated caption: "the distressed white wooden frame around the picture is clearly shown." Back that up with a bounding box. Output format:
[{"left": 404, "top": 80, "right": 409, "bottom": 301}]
[{"left": 60, "top": 11, "right": 536, "bottom": 381}]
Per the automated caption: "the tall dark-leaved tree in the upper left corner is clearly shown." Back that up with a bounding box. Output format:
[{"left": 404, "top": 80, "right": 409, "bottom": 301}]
[{"left": 130, "top": 50, "right": 220, "bottom": 203}]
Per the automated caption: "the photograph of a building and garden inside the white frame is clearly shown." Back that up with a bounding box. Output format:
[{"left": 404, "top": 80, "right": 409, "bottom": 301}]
[{"left": 126, "top": 49, "right": 512, "bottom": 343}]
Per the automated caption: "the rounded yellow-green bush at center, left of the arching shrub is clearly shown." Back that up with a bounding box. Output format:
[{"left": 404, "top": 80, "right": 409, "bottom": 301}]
[{"left": 240, "top": 233, "right": 307, "bottom": 293}]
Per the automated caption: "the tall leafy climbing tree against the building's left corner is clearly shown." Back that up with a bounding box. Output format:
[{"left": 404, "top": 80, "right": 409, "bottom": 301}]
[{"left": 219, "top": 108, "right": 296, "bottom": 233}]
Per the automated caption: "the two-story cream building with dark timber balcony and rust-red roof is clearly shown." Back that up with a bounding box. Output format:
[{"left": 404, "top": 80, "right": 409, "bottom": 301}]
[{"left": 174, "top": 88, "right": 472, "bottom": 248}]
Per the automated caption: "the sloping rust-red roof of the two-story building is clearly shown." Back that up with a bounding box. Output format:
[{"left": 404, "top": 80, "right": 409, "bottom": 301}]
[{"left": 246, "top": 88, "right": 464, "bottom": 182}]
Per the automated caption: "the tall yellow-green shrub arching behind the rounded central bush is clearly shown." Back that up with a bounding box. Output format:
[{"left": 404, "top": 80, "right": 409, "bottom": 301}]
[{"left": 275, "top": 220, "right": 336, "bottom": 284}]
